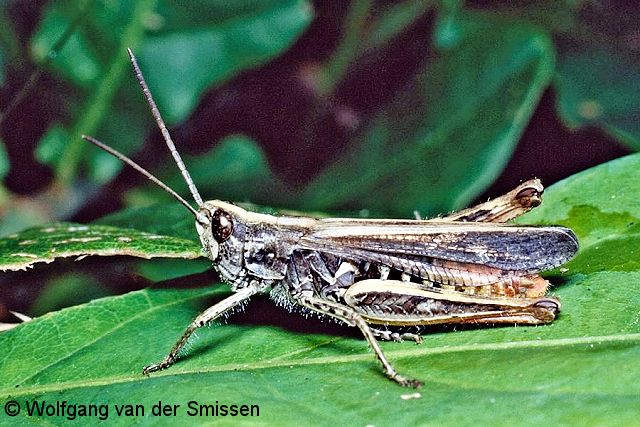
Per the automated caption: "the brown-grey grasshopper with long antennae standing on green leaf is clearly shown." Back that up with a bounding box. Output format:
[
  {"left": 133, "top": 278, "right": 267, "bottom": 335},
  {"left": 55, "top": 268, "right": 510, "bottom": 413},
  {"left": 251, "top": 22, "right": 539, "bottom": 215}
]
[{"left": 83, "top": 50, "right": 578, "bottom": 387}]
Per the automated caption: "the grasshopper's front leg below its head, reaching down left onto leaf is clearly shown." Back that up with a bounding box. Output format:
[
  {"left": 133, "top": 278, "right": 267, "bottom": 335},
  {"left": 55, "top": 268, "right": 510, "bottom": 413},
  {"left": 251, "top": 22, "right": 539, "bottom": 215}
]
[{"left": 142, "top": 285, "right": 258, "bottom": 375}]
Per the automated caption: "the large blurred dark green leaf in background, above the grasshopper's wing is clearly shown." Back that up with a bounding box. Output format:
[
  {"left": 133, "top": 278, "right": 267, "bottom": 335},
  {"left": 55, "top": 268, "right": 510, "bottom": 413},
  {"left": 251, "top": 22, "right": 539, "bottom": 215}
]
[{"left": 301, "top": 15, "right": 553, "bottom": 217}]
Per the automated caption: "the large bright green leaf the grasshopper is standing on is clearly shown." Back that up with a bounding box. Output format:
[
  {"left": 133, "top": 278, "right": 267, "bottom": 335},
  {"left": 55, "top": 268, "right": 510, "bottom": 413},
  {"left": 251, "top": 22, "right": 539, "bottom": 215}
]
[{"left": 0, "top": 155, "right": 640, "bottom": 425}]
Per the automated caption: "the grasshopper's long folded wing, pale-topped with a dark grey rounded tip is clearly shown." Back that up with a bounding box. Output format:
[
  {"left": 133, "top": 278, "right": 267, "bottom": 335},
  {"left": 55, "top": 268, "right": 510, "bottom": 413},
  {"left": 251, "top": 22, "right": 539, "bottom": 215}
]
[{"left": 298, "top": 219, "right": 578, "bottom": 273}]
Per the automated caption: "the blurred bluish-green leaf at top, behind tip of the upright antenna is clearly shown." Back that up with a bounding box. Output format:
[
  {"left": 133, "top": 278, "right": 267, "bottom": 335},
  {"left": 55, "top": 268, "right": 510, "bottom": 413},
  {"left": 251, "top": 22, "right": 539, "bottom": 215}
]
[{"left": 139, "top": 0, "right": 312, "bottom": 123}]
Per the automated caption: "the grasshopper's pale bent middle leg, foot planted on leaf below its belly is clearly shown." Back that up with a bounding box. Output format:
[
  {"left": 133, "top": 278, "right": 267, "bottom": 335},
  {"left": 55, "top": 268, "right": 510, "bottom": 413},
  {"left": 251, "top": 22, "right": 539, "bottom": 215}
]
[{"left": 294, "top": 295, "right": 422, "bottom": 388}]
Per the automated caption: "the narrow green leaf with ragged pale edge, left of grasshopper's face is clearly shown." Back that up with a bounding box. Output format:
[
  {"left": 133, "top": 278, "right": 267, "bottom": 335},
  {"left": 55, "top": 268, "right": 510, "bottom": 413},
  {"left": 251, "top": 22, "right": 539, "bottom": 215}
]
[{"left": 0, "top": 223, "right": 204, "bottom": 271}]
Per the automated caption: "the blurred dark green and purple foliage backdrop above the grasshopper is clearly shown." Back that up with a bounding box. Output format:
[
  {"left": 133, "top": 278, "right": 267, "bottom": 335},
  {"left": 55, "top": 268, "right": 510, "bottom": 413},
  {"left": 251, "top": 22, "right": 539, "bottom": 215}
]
[{"left": 0, "top": 0, "right": 640, "bottom": 227}]
